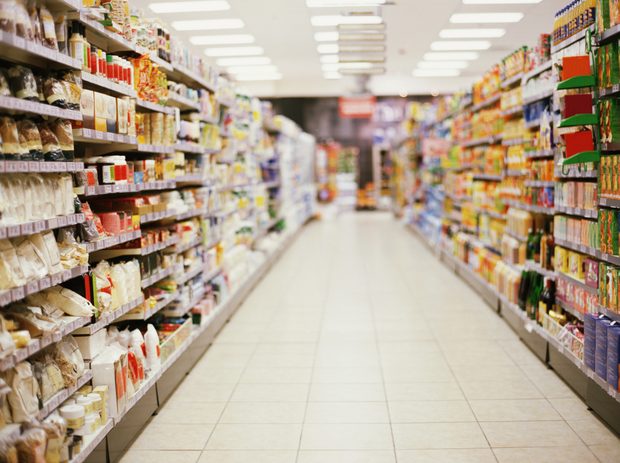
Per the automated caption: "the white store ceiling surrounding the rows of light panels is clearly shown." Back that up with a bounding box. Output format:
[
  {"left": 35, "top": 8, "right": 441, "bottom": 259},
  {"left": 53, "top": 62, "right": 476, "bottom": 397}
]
[{"left": 132, "top": 0, "right": 568, "bottom": 97}]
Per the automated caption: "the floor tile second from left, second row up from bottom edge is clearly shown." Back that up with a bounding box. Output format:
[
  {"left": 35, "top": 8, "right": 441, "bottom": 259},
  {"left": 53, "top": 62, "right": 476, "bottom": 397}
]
[{"left": 206, "top": 423, "right": 301, "bottom": 450}]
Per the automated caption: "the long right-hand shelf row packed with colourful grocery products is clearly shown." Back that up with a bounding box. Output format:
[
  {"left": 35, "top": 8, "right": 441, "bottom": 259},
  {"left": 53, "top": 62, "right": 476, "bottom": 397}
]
[{"left": 404, "top": 0, "right": 620, "bottom": 438}]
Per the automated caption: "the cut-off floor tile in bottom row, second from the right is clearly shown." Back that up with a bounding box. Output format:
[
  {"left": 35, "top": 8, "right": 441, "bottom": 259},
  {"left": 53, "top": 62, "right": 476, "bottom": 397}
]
[{"left": 493, "top": 444, "right": 598, "bottom": 463}]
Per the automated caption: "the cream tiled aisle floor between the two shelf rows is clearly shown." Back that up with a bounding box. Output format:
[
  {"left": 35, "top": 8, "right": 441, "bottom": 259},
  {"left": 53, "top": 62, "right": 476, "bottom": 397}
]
[{"left": 122, "top": 214, "right": 620, "bottom": 463}]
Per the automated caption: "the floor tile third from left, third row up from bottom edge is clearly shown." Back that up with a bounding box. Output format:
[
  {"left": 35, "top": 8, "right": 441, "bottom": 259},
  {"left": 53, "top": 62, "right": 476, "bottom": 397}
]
[{"left": 305, "top": 402, "right": 390, "bottom": 423}]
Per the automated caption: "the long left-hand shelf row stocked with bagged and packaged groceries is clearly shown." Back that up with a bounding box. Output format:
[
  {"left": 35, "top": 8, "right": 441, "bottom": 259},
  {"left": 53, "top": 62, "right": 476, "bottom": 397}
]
[{"left": 0, "top": 0, "right": 316, "bottom": 462}]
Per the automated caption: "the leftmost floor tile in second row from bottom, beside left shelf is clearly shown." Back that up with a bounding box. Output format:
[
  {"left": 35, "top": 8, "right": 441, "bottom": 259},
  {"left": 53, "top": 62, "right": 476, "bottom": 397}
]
[{"left": 132, "top": 423, "right": 213, "bottom": 450}]
